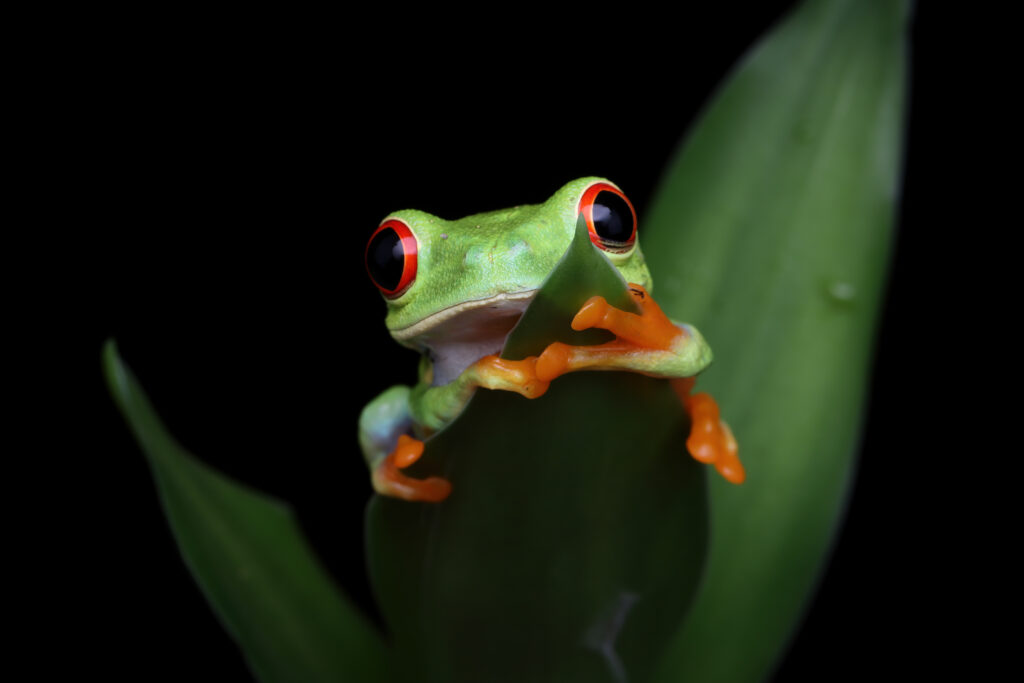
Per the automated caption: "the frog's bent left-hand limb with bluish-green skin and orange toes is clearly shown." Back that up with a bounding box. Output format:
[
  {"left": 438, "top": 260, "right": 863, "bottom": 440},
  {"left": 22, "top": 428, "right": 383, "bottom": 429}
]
[{"left": 359, "top": 355, "right": 548, "bottom": 503}]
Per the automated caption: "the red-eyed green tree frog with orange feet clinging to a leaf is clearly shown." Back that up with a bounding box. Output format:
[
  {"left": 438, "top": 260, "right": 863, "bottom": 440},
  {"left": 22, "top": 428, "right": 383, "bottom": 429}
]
[{"left": 358, "top": 176, "right": 745, "bottom": 503}]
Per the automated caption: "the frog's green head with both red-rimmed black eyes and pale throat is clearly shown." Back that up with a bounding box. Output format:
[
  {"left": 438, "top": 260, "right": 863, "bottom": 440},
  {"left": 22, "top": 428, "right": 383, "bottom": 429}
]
[{"left": 367, "top": 177, "right": 651, "bottom": 384}]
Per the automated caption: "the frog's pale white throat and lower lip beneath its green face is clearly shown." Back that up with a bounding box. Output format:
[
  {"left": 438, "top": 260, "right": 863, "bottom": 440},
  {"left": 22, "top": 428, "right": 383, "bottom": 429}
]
[{"left": 391, "top": 289, "right": 537, "bottom": 386}]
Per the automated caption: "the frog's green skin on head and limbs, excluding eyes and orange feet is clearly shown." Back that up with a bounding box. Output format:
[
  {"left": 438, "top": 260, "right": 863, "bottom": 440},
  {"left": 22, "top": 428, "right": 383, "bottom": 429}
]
[{"left": 359, "top": 177, "right": 711, "bottom": 470}]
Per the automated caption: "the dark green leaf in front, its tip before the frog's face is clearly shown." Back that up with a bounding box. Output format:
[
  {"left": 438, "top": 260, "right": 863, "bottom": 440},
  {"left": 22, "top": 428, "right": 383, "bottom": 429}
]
[{"left": 367, "top": 220, "right": 707, "bottom": 683}]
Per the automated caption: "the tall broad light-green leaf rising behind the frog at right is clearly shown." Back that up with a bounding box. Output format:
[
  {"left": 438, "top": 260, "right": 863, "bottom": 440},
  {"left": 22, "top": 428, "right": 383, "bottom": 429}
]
[{"left": 641, "top": 0, "right": 908, "bottom": 681}]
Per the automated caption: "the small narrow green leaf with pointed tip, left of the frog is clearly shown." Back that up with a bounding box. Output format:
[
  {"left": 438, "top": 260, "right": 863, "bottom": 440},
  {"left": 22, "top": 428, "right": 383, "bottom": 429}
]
[{"left": 103, "top": 341, "right": 385, "bottom": 683}]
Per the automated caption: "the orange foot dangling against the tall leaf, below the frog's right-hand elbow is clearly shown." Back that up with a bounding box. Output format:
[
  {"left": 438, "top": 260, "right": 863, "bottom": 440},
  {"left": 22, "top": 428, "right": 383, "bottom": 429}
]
[{"left": 672, "top": 377, "right": 746, "bottom": 484}]
